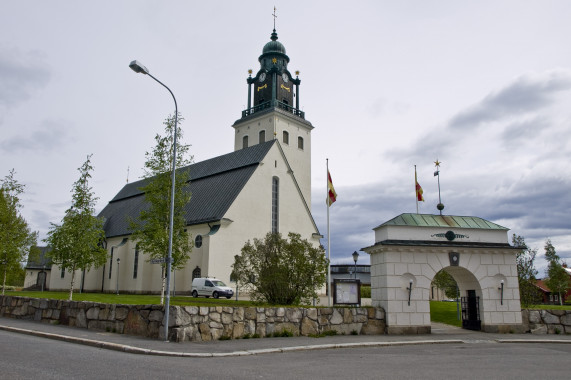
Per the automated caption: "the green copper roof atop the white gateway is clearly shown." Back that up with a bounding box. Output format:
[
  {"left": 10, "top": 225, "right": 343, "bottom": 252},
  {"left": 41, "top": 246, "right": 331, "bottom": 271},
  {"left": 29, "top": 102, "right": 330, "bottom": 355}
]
[{"left": 375, "top": 213, "right": 509, "bottom": 230}]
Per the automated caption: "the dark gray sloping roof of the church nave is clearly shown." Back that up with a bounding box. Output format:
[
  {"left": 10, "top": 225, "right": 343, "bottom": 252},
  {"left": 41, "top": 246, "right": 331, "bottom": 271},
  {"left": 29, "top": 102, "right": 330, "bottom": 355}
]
[{"left": 99, "top": 140, "right": 275, "bottom": 237}]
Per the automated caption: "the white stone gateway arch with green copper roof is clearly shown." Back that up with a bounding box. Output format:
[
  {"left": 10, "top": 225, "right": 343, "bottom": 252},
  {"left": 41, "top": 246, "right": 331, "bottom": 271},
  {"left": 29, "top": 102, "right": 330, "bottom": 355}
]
[{"left": 362, "top": 214, "right": 523, "bottom": 334}]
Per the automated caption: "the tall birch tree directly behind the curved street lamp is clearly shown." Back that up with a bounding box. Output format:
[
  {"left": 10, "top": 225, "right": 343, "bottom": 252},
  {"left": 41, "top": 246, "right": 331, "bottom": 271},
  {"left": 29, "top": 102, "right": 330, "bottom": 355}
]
[{"left": 129, "top": 115, "right": 192, "bottom": 304}]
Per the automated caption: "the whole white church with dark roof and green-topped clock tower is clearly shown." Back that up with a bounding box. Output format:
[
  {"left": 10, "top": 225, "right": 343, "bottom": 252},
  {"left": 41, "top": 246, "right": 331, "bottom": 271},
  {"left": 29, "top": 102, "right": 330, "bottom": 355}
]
[{"left": 43, "top": 30, "right": 322, "bottom": 294}]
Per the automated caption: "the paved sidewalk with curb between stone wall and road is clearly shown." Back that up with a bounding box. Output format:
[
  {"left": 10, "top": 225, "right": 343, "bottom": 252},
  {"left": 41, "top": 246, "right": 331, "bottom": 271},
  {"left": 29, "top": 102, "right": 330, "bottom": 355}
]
[{"left": 0, "top": 318, "right": 571, "bottom": 357}]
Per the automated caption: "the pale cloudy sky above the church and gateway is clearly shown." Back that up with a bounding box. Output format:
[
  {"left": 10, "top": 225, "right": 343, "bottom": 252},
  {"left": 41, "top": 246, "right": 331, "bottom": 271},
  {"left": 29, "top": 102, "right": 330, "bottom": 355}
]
[{"left": 0, "top": 0, "right": 571, "bottom": 276}]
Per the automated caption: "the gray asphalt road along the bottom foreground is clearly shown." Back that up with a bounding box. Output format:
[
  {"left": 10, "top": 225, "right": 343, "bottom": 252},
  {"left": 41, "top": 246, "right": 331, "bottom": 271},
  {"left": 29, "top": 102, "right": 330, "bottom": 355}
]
[{"left": 0, "top": 331, "right": 571, "bottom": 380}]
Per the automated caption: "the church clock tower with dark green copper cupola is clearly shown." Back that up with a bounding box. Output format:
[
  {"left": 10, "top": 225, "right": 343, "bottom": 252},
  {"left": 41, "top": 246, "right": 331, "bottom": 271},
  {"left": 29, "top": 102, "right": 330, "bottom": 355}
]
[{"left": 232, "top": 28, "right": 313, "bottom": 209}]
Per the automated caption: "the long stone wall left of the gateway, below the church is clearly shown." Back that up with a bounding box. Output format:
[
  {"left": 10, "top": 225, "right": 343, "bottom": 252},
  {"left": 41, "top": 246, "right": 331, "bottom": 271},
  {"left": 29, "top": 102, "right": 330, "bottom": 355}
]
[{"left": 0, "top": 296, "right": 385, "bottom": 342}]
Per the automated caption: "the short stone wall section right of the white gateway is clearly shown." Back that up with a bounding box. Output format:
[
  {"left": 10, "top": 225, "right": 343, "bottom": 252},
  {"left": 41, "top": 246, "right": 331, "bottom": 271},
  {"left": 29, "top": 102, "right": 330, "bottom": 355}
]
[{"left": 521, "top": 309, "right": 571, "bottom": 334}]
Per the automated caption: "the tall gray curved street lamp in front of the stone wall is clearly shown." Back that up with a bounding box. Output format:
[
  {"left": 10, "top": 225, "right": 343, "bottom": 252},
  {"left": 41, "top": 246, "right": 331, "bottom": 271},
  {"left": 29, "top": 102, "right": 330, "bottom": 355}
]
[{"left": 129, "top": 60, "right": 178, "bottom": 342}]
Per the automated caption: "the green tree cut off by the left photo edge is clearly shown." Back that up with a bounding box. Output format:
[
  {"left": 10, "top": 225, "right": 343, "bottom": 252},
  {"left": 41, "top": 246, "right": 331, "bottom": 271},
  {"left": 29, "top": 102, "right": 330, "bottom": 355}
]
[{"left": 0, "top": 169, "right": 37, "bottom": 295}]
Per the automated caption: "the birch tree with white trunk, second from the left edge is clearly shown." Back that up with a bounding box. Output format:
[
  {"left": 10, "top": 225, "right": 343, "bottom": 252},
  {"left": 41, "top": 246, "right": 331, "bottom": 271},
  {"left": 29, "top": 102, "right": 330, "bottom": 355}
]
[{"left": 44, "top": 155, "right": 107, "bottom": 301}]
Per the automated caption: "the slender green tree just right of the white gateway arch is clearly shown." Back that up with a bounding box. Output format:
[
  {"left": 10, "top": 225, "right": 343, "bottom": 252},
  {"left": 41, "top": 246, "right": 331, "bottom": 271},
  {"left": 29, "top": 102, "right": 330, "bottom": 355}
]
[{"left": 512, "top": 234, "right": 541, "bottom": 307}]
